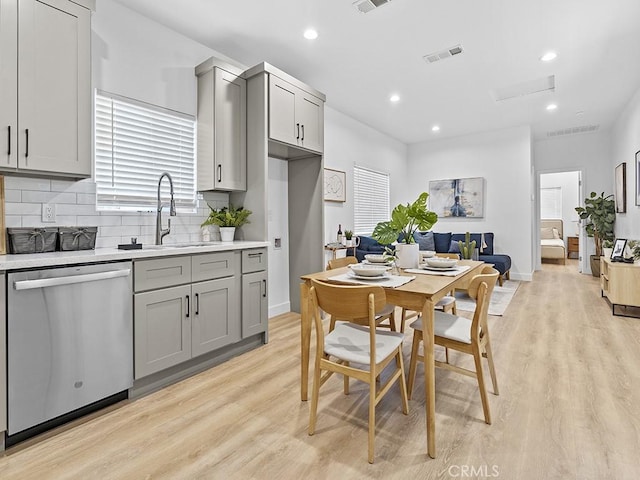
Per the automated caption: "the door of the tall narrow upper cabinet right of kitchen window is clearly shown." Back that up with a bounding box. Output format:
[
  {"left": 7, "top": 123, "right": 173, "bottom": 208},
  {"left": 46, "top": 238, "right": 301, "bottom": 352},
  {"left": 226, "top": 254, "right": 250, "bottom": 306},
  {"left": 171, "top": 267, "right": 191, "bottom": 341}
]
[{"left": 214, "top": 68, "right": 247, "bottom": 190}]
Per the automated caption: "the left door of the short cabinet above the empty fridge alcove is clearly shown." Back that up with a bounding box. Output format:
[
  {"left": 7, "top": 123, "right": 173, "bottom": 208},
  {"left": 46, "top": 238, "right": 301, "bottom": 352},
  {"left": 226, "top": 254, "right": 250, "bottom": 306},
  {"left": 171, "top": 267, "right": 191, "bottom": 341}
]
[{"left": 269, "top": 75, "right": 300, "bottom": 145}]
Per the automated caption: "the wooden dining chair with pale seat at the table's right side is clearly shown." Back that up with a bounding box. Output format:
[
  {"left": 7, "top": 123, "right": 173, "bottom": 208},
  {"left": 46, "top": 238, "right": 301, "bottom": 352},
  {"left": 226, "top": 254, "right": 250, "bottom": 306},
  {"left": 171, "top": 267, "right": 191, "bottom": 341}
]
[{"left": 407, "top": 266, "right": 500, "bottom": 424}]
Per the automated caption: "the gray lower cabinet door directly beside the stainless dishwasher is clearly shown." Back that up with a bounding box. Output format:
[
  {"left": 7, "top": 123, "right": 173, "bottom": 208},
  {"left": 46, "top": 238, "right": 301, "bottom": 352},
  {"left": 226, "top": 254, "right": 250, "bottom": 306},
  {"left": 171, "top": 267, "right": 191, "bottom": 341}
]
[{"left": 133, "top": 285, "right": 191, "bottom": 379}]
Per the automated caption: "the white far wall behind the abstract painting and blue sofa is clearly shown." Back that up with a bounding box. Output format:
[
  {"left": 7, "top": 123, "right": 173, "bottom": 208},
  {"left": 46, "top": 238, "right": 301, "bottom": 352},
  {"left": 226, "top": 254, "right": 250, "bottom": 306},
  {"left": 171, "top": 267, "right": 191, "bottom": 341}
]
[{"left": 406, "top": 127, "right": 534, "bottom": 280}]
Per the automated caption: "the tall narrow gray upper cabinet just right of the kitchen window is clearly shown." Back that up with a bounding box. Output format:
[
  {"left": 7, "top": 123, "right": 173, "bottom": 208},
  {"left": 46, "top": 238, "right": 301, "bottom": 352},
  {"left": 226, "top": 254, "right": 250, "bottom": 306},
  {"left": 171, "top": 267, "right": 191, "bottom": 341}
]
[{"left": 196, "top": 60, "right": 247, "bottom": 191}]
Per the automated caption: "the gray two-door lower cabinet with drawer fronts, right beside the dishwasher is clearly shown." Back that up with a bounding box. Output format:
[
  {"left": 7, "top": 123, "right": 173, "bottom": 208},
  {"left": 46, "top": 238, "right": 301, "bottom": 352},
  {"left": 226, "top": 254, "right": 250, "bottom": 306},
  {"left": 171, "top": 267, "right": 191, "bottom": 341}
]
[{"left": 134, "top": 251, "right": 241, "bottom": 379}]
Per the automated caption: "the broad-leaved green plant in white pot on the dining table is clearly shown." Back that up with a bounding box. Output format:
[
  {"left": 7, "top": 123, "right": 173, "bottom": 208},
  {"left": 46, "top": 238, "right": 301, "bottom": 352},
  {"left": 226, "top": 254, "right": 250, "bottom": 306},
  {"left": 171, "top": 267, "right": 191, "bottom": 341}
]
[{"left": 371, "top": 192, "right": 438, "bottom": 268}]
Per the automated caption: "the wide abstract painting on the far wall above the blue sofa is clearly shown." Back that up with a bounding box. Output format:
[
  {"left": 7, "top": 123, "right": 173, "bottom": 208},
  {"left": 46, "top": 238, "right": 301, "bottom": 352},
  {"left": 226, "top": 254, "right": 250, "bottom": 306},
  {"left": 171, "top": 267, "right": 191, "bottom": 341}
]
[{"left": 429, "top": 177, "right": 484, "bottom": 218}]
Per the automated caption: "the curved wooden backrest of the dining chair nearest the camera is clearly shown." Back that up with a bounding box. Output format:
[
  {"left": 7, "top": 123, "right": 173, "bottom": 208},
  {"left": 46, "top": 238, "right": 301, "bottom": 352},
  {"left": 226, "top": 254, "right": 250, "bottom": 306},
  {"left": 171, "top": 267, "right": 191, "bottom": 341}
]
[{"left": 309, "top": 280, "right": 387, "bottom": 363}]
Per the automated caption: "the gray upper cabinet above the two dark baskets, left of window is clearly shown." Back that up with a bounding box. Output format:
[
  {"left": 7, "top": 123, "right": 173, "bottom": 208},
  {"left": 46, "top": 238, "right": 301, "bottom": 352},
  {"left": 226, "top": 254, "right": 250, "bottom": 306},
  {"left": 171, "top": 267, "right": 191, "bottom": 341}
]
[{"left": 0, "top": 0, "right": 92, "bottom": 178}]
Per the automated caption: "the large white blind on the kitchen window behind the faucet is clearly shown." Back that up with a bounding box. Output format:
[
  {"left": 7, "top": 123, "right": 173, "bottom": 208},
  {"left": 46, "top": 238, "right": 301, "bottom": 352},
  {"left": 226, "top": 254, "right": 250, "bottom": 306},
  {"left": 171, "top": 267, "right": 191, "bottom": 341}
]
[{"left": 95, "top": 92, "right": 196, "bottom": 210}]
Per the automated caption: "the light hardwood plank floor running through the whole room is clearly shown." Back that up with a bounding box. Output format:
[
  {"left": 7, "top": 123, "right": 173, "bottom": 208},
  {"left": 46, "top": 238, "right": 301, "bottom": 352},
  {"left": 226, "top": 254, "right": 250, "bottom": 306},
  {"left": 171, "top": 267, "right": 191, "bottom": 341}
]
[{"left": 0, "top": 261, "right": 640, "bottom": 480}]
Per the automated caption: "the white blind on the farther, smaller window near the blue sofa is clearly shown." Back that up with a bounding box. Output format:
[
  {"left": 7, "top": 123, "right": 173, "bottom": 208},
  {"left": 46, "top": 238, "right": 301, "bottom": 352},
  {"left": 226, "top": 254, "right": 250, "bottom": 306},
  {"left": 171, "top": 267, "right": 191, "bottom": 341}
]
[{"left": 353, "top": 165, "right": 391, "bottom": 235}]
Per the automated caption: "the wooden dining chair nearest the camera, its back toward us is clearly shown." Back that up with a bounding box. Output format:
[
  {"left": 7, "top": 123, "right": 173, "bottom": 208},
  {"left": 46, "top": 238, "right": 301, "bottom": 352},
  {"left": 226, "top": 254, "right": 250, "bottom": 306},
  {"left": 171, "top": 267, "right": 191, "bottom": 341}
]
[{"left": 309, "top": 280, "right": 409, "bottom": 463}]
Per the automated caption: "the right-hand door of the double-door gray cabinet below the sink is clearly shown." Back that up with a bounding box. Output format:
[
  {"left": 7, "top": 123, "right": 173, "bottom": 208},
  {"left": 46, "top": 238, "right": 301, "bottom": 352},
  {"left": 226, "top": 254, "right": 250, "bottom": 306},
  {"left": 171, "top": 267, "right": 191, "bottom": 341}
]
[{"left": 192, "top": 277, "right": 240, "bottom": 357}]
